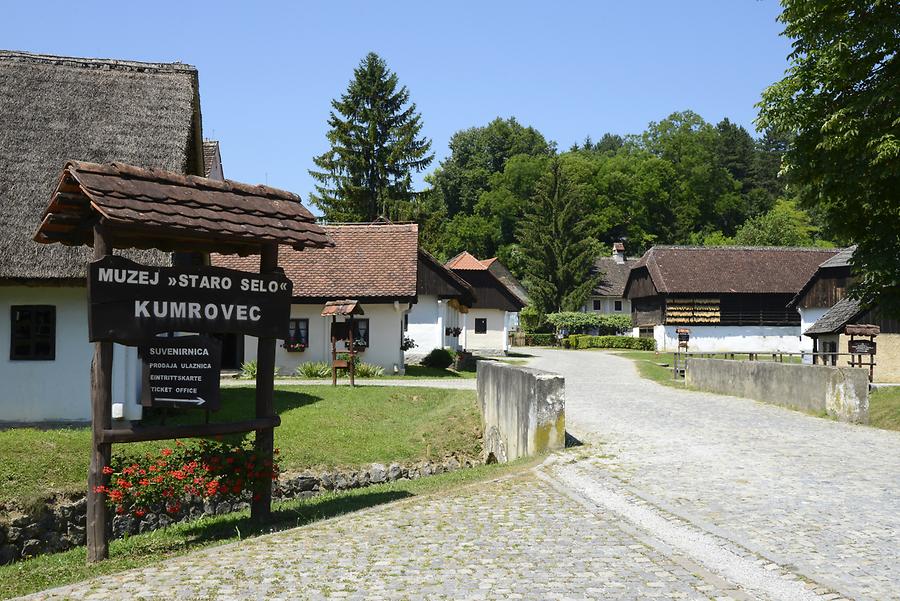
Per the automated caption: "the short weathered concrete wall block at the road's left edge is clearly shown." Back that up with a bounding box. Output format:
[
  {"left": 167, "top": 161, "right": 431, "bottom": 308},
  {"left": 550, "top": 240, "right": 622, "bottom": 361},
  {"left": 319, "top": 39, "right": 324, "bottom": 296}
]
[{"left": 476, "top": 361, "right": 566, "bottom": 463}]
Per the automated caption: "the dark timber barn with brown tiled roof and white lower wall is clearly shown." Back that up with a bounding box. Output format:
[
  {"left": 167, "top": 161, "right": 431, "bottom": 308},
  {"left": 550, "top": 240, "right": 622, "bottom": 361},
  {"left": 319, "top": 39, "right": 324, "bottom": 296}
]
[{"left": 625, "top": 246, "right": 838, "bottom": 353}]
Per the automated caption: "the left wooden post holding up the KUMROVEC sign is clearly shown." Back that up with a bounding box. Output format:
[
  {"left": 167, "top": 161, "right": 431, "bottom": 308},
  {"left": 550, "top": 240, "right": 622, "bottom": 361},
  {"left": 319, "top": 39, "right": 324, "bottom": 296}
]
[{"left": 87, "top": 226, "right": 113, "bottom": 563}]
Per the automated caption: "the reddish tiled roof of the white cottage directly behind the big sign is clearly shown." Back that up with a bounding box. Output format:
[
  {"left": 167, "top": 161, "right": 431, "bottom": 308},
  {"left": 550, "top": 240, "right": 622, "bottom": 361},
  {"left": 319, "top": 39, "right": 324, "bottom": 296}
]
[{"left": 211, "top": 224, "right": 419, "bottom": 300}]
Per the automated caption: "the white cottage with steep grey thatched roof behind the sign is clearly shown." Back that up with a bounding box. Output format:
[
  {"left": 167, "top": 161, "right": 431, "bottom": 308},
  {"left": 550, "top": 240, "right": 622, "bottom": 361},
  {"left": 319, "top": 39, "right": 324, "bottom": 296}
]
[{"left": 0, "top": 51, "right": 204, "bottom": 422}]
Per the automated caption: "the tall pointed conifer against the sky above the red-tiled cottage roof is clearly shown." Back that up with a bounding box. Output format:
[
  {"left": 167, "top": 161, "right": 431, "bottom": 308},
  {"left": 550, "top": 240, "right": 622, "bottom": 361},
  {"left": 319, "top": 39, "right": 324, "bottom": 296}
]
[{"left": 309, "top": 52, "right": 434, "bottom": 221}]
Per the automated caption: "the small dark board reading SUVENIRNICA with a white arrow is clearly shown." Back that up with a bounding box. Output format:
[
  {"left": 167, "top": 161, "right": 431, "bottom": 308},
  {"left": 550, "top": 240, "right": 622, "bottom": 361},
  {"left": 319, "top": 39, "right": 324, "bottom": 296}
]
[{"left": 139, "top": 336, "right": 222, "bottom": 411}]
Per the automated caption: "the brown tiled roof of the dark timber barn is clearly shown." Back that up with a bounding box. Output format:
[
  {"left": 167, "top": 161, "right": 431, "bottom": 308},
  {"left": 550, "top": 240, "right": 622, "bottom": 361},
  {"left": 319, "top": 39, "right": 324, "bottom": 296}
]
[{"left": 631, "top": 246, "right": 840, "bottom": 294}]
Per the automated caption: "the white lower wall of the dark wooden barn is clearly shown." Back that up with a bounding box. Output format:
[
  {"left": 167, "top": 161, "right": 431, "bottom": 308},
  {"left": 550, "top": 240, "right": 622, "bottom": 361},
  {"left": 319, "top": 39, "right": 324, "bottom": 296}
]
[{"left": 653, "top": 325, "right": 801, "bottom": 353}]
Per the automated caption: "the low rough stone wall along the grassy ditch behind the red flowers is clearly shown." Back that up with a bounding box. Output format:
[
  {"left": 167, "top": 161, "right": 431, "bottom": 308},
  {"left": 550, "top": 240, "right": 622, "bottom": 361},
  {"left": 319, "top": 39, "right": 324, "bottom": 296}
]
[{"left": 0, "top": 455, "right": 481, "bottom": 565}]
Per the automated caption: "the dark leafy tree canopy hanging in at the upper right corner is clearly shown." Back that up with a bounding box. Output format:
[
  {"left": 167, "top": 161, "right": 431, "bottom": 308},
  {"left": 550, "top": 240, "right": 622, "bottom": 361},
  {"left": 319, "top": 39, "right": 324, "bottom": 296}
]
[{"left": 758, "top": 0, "right": 900, "bottom": 313}]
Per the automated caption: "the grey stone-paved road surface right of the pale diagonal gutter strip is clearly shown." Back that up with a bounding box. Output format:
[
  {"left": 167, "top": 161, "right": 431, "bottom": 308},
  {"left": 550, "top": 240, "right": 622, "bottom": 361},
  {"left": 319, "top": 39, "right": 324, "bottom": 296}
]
[{"left": 531, "top": 350, "right": 900, "bottom": 599}]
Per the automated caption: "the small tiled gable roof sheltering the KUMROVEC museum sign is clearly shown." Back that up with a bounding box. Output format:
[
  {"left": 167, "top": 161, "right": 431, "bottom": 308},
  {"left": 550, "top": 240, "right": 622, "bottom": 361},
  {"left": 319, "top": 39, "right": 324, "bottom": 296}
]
[{"left": 35, "top": 161, "right": 331, "bottom": 254}]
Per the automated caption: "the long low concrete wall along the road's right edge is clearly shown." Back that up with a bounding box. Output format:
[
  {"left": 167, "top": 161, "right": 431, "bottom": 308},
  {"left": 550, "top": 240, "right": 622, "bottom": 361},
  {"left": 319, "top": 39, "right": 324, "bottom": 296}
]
[{"left": 685, "top": 359, "right": 869, "bottom": 424}]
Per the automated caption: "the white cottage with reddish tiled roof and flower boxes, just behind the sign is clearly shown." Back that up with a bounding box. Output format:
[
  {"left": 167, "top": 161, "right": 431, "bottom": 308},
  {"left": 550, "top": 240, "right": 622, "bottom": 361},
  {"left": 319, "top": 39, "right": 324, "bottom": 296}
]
[{"left": 211, "top": 223, "right": 471, "bottom": 374}]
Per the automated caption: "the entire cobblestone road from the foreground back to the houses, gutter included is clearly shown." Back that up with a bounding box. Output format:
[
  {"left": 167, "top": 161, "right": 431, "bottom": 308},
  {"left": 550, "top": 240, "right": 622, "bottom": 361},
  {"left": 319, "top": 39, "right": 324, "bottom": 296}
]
[{"left": 17, "top": 351, "right": 900, "bottom": 601}]
